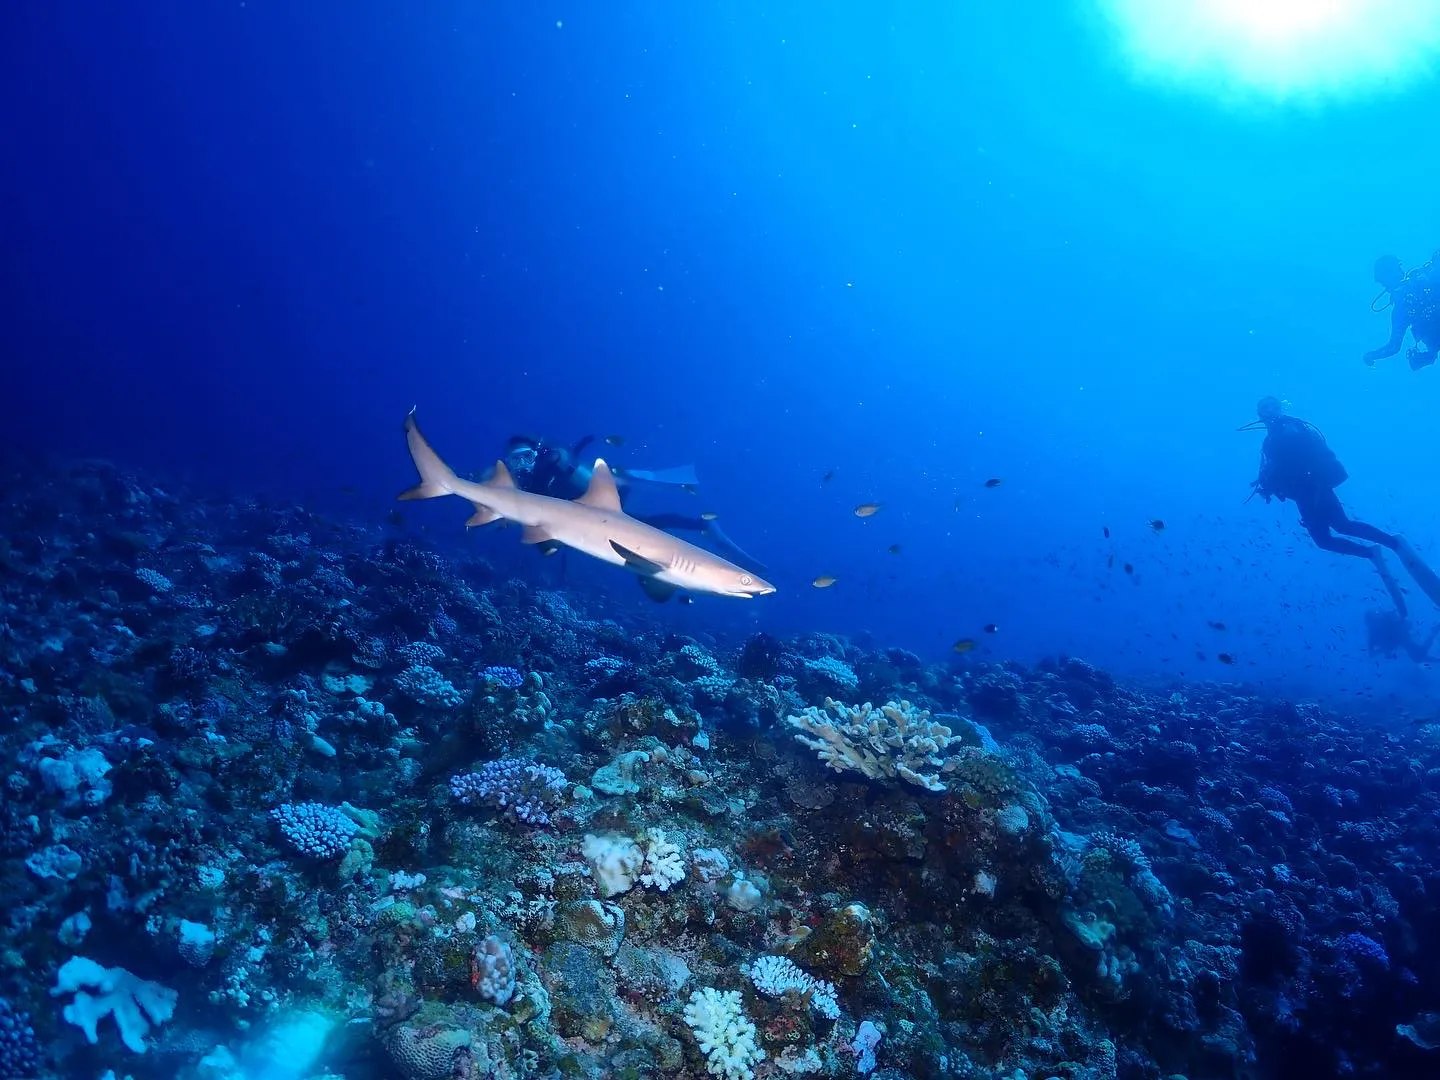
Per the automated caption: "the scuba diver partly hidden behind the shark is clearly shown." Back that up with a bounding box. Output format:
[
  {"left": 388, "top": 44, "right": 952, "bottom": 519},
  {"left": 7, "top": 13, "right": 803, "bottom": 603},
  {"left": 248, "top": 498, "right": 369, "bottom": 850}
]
[{"left": 504, "top": 435, "right": 766, "bottom": 572}]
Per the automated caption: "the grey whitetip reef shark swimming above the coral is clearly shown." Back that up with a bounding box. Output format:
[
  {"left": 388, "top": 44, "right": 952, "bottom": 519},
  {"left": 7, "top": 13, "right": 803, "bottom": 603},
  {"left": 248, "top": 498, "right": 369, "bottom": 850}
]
[{"left": 400, "top": 409, "right": 775, "bottom": 600}]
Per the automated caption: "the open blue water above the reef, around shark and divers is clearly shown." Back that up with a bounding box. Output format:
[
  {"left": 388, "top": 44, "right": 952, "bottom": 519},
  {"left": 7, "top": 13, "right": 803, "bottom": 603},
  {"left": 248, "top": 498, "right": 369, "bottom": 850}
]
[{"left": 0, "top": 1, "right": 1440, "bottom": 708}]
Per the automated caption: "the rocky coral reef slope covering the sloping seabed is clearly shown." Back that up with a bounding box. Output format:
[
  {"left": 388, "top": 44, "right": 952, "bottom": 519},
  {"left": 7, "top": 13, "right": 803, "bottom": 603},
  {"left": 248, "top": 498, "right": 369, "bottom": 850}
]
[{"left": 0, "top": 462, "right": 1440, "bottom": 1080}]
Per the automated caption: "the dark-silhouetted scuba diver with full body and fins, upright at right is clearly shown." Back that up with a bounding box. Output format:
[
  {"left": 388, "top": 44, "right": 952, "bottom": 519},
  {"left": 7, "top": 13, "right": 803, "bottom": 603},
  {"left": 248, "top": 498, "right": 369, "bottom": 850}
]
[{"left": 1241, "top": 397, "right": 1440, "bottom": 618}]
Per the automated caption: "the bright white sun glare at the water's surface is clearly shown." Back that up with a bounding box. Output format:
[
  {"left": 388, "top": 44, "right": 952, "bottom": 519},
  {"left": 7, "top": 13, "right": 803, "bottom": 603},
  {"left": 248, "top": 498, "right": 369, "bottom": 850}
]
[{"left": 1103, "top": 0, "right": 1440, "bottom": 101}]
